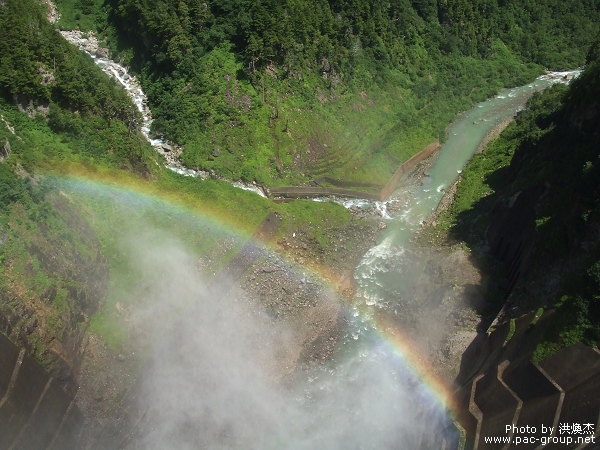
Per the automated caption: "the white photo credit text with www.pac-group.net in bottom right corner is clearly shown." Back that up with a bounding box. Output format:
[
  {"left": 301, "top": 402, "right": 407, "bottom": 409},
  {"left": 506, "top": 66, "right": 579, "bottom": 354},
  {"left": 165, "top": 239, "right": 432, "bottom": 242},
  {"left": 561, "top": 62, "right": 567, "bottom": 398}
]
[{"left": 483, "top": 423, "right": 596, "bottom": 445}]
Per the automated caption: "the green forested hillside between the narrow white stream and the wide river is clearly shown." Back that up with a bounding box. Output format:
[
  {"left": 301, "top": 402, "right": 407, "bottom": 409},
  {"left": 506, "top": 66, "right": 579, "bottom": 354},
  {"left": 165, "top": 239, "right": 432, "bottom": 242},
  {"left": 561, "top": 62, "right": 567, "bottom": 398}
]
[{"left": 52, "top": 0, "right": 600, "bottom": 184}]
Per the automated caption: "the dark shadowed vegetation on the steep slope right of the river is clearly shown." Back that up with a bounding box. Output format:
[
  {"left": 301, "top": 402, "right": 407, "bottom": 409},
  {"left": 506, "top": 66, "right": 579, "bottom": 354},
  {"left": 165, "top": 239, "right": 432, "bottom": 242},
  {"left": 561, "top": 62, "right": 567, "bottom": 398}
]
[{"left": 438, "top": 37, "right": 600, "bottom": 360}]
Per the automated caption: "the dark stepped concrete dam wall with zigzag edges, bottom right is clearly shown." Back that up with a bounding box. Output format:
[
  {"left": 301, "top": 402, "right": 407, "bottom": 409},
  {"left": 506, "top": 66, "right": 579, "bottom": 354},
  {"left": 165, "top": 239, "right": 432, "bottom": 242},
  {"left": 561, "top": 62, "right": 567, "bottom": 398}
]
[{"left": 455, "top": 311, "right": 600, "bottom": 450}]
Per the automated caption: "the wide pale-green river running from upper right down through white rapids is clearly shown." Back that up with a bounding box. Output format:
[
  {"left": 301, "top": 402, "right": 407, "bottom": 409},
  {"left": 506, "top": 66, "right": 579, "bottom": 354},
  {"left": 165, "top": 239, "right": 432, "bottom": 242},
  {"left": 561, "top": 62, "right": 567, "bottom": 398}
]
[{"left": 314, "top": 70, "right": 580, "bottom": 448}]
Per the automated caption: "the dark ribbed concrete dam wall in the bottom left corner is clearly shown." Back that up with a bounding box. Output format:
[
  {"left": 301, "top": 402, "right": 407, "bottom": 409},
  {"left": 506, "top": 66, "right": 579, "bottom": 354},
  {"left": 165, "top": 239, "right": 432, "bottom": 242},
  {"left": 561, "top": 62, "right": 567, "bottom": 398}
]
[{"left": 0, "top": 333, "right": 85, "bottom": 450}]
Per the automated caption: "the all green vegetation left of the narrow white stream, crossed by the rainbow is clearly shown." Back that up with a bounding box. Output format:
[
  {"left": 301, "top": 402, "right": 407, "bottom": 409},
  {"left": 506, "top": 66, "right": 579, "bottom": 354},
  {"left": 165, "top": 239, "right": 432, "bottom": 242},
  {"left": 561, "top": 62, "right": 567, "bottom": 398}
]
[{"left": 0, "top": 0, "right": 372, "bottom": 370}]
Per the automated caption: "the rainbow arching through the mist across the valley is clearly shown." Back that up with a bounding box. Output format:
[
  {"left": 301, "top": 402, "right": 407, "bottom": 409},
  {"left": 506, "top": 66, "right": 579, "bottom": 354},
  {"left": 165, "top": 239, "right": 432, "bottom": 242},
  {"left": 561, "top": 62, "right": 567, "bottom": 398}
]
[{"left": 50, "top": 166, "right": 455, "bottom": 426}]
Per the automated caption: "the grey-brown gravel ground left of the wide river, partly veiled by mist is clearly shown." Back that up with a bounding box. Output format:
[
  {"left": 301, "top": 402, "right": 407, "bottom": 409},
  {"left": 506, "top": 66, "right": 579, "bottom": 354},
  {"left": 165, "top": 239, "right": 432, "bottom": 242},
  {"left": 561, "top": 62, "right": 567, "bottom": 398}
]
[{"left": 77, "top": 207, "right": 380, "bottom": 443}]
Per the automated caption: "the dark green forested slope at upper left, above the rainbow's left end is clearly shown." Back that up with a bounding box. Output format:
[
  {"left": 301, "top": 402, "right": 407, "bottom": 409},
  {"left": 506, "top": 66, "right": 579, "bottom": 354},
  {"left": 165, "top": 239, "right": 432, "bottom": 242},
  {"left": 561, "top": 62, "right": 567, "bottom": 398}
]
[{"left": 0, "top": 0, "right": 159, "bottom": 174}]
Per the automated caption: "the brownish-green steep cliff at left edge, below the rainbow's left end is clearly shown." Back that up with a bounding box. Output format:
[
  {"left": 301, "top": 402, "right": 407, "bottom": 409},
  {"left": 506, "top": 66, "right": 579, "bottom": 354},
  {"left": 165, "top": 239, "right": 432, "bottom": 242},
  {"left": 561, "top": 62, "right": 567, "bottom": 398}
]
[{"left": 0, "top": 164, "right": 108, "bottom": 374}]
